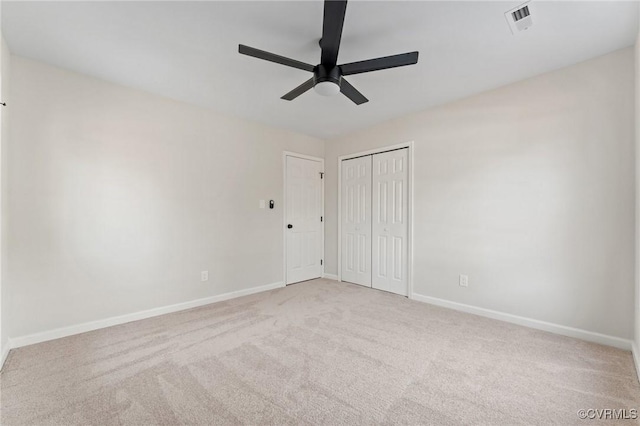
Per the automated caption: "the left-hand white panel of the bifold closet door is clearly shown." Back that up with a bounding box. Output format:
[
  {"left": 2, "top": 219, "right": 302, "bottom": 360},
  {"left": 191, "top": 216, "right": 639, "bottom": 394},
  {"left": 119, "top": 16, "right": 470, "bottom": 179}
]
[{"left": 340, "top": 155, "right": 371, "bottom": 287}]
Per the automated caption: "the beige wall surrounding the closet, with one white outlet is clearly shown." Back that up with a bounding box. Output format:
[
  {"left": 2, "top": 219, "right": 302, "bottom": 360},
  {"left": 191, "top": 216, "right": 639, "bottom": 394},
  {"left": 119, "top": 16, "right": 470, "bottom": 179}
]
[{"left": 325, "top": 48, "right": 635, "bottom": 339}]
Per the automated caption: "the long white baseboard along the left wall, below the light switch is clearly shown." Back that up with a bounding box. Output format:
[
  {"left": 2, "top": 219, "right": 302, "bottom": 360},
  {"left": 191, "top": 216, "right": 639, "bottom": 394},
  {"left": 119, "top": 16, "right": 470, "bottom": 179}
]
[{"left": 7, "top": 282, "right": 284, "bottom": 352}]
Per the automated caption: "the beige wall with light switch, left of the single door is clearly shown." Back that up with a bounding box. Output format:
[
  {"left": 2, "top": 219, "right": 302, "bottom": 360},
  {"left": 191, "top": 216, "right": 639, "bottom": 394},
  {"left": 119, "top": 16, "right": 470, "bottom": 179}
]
[{"left": 6, "top": 56, "right": 324, "bottom": 338}]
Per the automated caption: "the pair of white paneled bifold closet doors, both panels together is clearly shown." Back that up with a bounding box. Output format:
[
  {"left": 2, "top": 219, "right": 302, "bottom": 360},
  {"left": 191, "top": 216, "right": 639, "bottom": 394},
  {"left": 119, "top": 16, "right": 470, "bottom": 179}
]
[{"left": 340, "top": 148, "right": 409, "bottom": 296}]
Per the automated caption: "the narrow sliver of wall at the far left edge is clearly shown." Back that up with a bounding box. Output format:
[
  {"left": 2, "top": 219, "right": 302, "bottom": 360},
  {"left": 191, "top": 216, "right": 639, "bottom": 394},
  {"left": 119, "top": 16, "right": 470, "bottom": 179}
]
[{"left": 0, "top": 38, "right": 11, "bottom": 356}]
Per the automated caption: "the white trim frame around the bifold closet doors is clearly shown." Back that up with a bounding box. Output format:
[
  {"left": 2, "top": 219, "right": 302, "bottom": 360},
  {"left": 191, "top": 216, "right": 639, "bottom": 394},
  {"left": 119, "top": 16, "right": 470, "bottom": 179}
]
[{"left": 336, "top": 141, "right": 413, "bottom": 299}]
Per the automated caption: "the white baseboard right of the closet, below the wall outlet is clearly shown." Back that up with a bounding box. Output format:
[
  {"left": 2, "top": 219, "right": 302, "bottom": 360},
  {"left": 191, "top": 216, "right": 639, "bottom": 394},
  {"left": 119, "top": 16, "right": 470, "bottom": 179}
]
[{"left": 411, "top": 293, "right": 632, "bottom": 351}]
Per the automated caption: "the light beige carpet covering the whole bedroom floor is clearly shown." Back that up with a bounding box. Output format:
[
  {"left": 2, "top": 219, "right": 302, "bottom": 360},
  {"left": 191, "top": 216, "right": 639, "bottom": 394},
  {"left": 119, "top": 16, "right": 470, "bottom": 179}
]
[{"left": 0, "top": 280, "right": 640, "bottom": 425}]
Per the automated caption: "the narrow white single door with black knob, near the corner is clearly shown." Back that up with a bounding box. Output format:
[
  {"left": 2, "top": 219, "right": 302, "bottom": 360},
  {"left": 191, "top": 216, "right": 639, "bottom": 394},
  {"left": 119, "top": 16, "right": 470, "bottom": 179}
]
[{"left": 286, "top": 156, "right": 323, "bottom": 284}]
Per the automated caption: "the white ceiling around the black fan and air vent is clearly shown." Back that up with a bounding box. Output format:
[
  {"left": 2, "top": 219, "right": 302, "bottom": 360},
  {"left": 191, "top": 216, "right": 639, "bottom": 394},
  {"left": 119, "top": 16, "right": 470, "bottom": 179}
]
[{"left": 2, "top": 0, "right": 638, "bottom": 138}]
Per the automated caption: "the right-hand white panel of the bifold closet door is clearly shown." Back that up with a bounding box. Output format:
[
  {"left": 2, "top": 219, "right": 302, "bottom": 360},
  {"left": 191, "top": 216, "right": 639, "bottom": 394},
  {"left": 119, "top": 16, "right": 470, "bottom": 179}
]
[{"left": 371, "top": 149, "right": 409, "bottom": 296}]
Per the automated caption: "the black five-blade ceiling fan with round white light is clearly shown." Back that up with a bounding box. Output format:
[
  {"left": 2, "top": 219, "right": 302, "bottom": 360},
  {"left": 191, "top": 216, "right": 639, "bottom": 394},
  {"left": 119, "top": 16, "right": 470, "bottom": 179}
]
[{"left": 238, "top": 0, "right": 418, "bottom": 105}]
